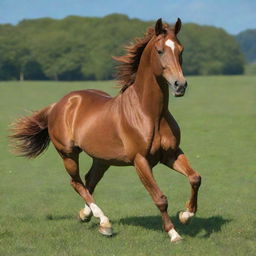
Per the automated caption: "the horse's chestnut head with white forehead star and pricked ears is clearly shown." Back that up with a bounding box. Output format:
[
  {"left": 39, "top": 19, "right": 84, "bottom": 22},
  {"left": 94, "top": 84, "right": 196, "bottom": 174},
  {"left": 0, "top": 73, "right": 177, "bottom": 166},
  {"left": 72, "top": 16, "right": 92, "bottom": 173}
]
[{"left": 151, "top": 18, "right": 187, "bottom": 97}]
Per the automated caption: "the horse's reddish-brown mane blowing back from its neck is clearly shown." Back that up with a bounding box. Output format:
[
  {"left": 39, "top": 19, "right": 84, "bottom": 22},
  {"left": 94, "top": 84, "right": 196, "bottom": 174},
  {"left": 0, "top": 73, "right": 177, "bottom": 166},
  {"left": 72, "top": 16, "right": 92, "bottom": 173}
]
[{"left": 113, "top": 27, "right": 155, "bottom": 93}]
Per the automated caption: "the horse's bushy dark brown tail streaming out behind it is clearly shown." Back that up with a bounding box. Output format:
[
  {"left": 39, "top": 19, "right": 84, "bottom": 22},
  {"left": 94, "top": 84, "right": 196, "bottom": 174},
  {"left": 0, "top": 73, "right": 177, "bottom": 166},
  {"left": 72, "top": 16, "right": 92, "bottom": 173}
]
[{"left": 9, "top": 106, "right": 51, "bottom": 158}]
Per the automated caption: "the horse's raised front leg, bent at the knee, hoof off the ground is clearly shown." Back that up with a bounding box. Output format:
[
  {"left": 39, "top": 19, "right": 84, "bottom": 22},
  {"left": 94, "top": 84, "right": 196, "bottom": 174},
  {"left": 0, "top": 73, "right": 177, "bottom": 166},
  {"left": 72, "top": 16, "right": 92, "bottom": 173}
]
[{"left": 161, "top": 149, "right": 201, "bottom": 224}]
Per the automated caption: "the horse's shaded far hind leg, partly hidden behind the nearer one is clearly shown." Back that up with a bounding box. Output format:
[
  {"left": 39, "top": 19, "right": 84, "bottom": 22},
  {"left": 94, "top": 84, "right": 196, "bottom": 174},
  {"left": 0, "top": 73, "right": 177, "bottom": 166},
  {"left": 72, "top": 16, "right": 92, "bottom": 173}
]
[{"left": 79, "top": 159, "right": 109, "bottom": 222}]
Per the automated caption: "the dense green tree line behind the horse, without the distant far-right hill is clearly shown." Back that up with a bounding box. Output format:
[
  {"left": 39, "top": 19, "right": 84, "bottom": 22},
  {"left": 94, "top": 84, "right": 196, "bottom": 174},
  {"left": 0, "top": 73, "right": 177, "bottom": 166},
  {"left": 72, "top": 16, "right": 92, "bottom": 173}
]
[{"left": 0, "top": 14, "right": 244, "bottom": 80}]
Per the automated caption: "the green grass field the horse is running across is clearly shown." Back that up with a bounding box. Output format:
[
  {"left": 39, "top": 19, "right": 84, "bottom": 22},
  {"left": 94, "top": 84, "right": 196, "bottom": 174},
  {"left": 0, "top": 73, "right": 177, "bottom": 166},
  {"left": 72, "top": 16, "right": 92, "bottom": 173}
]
[{"left": 0, "top": 76, "right": 256, "bottom": 256}]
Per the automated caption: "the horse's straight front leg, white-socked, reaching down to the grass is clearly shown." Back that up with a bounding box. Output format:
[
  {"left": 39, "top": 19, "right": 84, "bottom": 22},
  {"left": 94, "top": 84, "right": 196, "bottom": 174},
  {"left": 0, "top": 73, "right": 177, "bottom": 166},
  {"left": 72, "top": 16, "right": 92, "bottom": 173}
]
[{"left": 134, "top": 154, "right": 182, "bottom": 242}]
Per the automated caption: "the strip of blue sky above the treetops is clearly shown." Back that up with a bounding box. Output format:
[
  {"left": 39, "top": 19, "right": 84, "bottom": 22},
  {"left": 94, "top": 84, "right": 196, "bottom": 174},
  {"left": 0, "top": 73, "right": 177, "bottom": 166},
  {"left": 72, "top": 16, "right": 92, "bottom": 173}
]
[{"left": 0, "top": 0, "right": 256, "bottom": 34}]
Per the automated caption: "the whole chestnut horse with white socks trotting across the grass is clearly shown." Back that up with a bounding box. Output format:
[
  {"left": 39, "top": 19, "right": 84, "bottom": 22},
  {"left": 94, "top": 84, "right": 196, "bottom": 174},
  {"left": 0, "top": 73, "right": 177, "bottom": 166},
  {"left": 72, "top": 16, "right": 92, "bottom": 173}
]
[{"left": 11, "top": 19, "right": 201, "bottom": 242}]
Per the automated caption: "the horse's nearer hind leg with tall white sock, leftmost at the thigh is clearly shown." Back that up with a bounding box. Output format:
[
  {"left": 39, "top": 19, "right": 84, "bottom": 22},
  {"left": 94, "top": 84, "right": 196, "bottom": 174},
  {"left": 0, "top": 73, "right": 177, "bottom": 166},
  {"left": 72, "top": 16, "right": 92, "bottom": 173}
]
[{"left": 60, "top": 151, "right": 112, "bottom": 236}]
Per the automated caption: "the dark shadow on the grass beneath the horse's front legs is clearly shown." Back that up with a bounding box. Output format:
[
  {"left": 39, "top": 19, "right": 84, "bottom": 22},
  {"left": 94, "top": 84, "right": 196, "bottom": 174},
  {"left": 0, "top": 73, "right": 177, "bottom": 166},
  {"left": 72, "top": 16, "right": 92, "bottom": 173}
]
[{"left": 119, "top": 216, "right": 232, "bottom": 238}]
